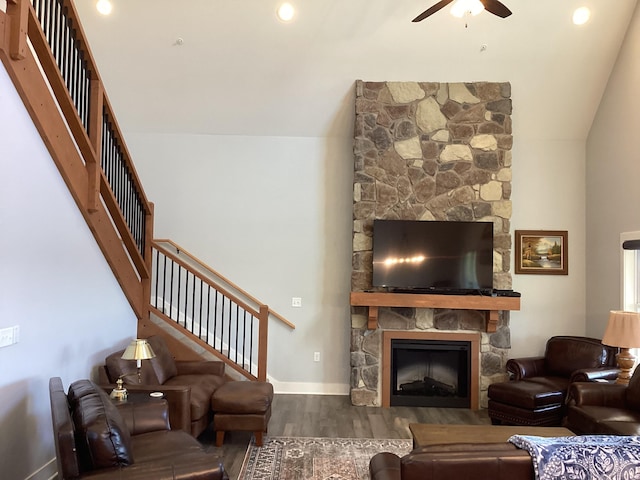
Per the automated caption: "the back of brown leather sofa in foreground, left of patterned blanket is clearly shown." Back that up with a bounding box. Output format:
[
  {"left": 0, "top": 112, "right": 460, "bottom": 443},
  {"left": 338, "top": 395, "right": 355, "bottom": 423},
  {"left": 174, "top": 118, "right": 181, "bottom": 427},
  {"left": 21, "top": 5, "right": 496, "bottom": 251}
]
[{"left": 369, "top": 442, "right": 535, "bottom": 480}]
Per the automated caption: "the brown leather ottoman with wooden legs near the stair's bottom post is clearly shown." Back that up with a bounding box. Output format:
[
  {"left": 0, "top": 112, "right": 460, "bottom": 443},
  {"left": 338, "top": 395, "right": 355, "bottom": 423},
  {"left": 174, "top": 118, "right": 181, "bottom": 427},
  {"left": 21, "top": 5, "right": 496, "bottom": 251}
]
[{"left": 211, "top": 381, "right": 273, "bottom": 447}]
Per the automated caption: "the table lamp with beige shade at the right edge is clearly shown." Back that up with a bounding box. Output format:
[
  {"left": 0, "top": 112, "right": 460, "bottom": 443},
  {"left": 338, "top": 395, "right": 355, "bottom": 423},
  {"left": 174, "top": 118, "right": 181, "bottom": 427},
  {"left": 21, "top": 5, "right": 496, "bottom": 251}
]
[{"left": 602, "top": 310, "right": 640, "bottom": 385}]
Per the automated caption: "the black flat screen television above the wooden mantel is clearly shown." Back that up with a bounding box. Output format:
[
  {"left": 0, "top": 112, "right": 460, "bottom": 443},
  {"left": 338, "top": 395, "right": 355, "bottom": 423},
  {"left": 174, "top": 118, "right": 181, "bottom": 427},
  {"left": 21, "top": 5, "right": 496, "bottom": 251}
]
[{"left": 372, "top": 220, "right": 493, "bottom": 293}]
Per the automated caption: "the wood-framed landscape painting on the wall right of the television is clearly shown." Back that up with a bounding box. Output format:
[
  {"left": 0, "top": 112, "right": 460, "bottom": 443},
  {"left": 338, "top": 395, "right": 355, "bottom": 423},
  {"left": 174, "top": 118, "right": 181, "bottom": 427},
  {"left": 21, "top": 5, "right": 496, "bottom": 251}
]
[{"left": 514, "top": 230, "right": 569, "bottom": 275}]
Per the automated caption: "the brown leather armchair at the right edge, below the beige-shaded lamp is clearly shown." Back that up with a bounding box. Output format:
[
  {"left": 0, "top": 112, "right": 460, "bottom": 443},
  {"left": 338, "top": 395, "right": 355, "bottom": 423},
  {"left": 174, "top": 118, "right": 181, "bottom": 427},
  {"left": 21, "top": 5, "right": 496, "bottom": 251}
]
[{"left": 565, "top": 368, "right": 640, "bottom": 435}]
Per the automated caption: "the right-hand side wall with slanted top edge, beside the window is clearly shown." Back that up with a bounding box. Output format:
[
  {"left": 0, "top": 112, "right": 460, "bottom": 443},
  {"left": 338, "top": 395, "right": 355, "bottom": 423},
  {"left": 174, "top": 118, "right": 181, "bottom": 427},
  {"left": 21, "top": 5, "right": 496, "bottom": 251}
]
[{"left": 587, "top": 0, "right": 640, "bottom": 336}]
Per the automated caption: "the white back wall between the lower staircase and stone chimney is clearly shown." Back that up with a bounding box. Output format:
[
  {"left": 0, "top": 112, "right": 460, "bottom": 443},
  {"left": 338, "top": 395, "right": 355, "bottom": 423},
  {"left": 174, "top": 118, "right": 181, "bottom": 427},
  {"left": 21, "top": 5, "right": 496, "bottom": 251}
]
[{"left": 127, "top": 135, "right": 353, "bottom": 393}]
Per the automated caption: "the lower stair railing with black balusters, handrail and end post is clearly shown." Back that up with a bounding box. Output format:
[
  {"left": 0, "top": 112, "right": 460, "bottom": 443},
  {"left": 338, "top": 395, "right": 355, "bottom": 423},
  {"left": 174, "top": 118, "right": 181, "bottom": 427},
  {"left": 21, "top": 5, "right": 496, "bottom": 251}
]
[{"left": 151, "top": 240, "right": 295, "bottom": 380}]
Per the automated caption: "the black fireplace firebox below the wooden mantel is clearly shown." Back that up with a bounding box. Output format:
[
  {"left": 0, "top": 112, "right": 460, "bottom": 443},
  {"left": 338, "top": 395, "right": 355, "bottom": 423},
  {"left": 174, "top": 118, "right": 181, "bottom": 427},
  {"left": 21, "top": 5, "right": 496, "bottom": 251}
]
[{"left": 390, "top": 339, "right": 471, "bottom": 408}]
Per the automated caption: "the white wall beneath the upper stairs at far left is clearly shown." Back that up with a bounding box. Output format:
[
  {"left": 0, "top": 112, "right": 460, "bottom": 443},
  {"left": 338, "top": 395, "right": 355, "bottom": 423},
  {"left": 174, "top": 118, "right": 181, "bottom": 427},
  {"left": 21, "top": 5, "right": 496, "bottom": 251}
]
[{"left": 0, "top": 66, "right": 137, "bottom": 479}]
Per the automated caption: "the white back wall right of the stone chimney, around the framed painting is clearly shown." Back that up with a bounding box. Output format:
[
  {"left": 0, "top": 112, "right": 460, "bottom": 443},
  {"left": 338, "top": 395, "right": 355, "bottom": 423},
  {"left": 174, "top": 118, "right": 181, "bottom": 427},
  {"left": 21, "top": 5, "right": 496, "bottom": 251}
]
[{"left": 510, "top": 137, "right": 586, "bottom": 357}]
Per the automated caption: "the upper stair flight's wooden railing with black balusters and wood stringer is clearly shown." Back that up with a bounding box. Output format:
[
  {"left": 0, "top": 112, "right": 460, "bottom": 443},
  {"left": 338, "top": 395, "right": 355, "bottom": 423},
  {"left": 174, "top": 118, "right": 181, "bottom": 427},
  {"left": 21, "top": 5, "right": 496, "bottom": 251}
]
[{"left": 0, "top": 0, "right": 153, "bottom": 318}]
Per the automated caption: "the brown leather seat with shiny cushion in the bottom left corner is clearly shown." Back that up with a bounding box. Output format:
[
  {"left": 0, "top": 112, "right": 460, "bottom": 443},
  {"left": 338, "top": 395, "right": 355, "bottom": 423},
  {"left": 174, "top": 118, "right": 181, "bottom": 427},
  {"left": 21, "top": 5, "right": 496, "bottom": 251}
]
[{"left": 49, "top": 377, "right": 228, "bottom": 480}]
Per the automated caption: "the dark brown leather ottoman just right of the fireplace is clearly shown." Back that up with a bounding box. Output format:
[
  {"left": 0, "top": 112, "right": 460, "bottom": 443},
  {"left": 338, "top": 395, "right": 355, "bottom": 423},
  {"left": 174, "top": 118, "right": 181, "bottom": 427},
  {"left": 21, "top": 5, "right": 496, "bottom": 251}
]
[{"left": 487, "top": 381, "right": 565, "bottom": 427}]
